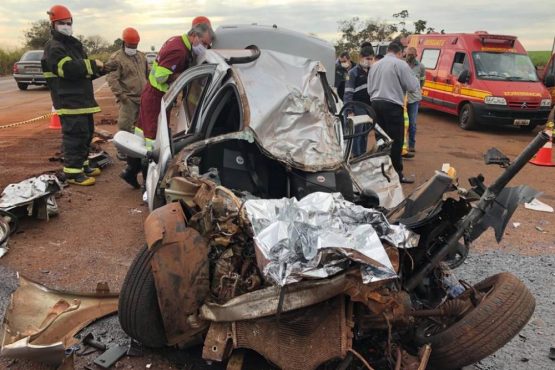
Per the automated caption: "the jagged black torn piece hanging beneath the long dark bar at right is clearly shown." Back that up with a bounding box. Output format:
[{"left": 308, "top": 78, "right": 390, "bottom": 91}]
[{"left": 469, "top": 185, "right": 538, "bottom": 243}]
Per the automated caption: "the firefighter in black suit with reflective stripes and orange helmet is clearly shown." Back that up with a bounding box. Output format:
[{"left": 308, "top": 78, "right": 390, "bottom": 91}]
[{"left": 41, "top": 5, "right": 104, "bottom": 186}]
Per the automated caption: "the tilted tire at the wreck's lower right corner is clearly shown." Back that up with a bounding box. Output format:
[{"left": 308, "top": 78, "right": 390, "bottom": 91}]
[{"left": 416, "top": 272, "right": 536, "bottom": 370}]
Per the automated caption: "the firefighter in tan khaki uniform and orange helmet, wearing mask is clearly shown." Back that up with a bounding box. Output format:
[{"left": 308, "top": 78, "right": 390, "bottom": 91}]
[{"left": 106, "top": 27, "right": 148, "bottom": 160}]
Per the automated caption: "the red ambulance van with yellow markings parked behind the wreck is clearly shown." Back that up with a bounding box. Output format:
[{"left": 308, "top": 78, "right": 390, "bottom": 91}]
[{"left": 406, "top": 31, "right": 552, "bottom": 130}]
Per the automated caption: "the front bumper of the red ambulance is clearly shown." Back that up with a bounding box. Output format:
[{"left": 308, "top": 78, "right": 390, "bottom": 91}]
[{"left": 472, "top": 103, "right": 550, "bottom": 126}]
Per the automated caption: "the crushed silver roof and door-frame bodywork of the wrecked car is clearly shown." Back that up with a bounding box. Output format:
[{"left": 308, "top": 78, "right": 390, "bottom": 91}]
[{"left": 114, "top": 45, "right": 403, "bottom": 210}]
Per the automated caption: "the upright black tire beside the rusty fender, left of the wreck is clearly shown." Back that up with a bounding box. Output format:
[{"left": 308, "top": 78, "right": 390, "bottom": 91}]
[{"left": 118, "top": 245, "right": 167, "bottom": 348}]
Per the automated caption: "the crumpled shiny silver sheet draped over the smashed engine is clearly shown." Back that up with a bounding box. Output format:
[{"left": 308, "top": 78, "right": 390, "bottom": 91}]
[{"left": 245, "top": 192, "right": 415, "bottom": 286}]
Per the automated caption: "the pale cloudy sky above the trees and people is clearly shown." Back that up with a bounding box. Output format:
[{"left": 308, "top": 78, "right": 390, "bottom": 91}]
[{"left": 0, "top": 0, "right": 555, "bottom": 51}]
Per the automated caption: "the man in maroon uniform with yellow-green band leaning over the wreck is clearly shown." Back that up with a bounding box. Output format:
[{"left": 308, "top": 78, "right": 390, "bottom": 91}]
[{"left": 121, "top": 17, "right": 214, "bottom": 189}]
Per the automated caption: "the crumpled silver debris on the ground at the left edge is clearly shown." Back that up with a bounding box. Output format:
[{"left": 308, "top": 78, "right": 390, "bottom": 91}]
[{"left": 0, "top": 175, "right": 62, "bottom": 219}]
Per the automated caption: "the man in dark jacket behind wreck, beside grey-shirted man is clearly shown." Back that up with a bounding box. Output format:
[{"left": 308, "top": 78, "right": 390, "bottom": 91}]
[{"left": 343, "top": 42, "right": 374, "bottom": 156}]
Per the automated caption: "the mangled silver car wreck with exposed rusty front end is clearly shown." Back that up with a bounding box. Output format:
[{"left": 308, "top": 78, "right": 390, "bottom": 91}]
[{"left": 114, "top": 42, "right": 548, "bottom": 369}]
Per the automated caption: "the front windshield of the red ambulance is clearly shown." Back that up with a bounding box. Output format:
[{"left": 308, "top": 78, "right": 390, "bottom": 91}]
[{"left": 472, "top": 52, "right": 538, "bottom": 82}]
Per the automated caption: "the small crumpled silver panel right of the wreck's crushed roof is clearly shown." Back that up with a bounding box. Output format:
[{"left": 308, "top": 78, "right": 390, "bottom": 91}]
[{"left": 350, "top": 155, "right": 405, "bottom": 209}]
